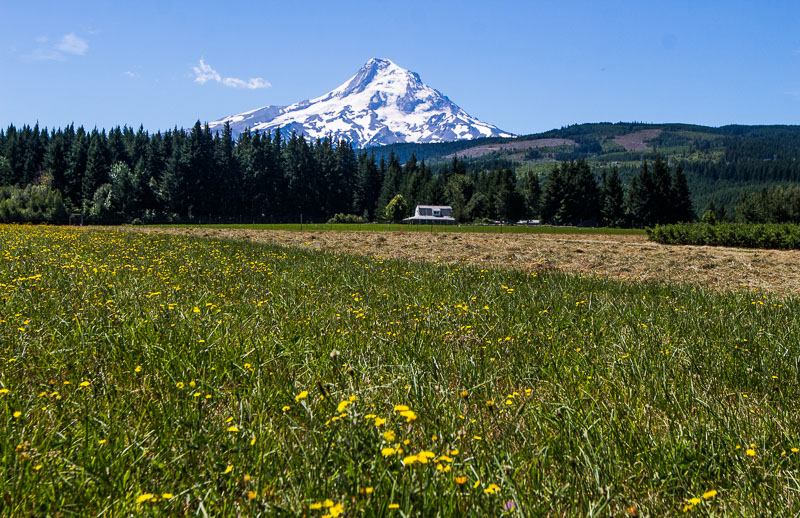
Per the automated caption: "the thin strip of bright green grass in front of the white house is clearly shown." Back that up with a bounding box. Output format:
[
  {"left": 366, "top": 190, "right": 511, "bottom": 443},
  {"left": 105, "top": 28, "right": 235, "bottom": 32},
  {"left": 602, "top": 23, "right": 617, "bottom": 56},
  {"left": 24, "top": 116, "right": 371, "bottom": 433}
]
[{"left": 142, "top": 223, "right": 645, "bottom": 239}]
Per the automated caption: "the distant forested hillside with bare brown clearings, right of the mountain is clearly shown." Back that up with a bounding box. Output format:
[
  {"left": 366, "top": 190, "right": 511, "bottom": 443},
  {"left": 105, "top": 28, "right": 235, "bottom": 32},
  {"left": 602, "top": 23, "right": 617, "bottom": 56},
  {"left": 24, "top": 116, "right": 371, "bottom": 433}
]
[{"left": 374, "top": 123, "right": 800, "bottom": 214}]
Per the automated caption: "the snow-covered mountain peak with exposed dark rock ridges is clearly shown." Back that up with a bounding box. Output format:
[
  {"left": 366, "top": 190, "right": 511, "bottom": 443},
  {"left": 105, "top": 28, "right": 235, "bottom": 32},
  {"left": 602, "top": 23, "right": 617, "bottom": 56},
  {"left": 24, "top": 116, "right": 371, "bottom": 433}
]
[{"left": 209, "top": 58, "right": 514, "bottom": 148}]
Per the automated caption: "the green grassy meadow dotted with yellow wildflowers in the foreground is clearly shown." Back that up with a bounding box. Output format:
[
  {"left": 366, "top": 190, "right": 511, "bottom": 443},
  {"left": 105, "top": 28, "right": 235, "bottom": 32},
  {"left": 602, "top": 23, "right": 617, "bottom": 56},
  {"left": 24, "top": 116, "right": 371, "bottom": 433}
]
[{"left": 0, "top": 226, "right": 800, "bottom": 517}]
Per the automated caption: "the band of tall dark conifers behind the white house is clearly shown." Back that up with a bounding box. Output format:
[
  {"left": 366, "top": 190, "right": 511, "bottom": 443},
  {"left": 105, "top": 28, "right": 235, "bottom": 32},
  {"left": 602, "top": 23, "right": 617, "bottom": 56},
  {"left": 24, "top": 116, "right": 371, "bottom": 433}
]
[{"left": 0, "top": 122, "right": 694, "bottom": 226}]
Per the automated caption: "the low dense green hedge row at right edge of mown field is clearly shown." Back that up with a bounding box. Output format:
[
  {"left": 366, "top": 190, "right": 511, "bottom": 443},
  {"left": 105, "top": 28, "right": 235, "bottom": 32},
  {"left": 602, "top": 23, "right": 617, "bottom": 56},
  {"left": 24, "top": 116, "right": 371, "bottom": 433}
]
[{"left": 647, "top": 223, "right": 800, "bottom": 250}]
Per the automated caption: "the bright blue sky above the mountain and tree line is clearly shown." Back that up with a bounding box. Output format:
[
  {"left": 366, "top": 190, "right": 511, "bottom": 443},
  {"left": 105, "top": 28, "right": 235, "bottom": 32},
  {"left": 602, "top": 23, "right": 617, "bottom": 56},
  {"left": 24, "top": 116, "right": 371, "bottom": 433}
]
[{"left": 0, "top": 0, "right": 800, "bottom": 134}]
